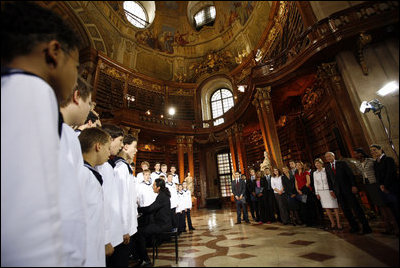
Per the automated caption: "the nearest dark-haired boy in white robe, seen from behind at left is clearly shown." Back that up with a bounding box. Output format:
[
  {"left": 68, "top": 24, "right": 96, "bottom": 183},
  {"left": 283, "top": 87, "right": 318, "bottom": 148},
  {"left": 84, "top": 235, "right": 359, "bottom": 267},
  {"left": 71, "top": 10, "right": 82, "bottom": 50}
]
[{"left": 1, "top": 1, "right": 79, "bottom": 267}]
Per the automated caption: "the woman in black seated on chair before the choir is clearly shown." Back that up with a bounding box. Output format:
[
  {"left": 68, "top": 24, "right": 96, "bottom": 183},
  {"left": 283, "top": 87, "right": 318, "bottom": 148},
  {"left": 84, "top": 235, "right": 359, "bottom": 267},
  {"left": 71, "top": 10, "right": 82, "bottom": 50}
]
[{"left": 134, "top": 179, "right": 172, "bottom": 266}]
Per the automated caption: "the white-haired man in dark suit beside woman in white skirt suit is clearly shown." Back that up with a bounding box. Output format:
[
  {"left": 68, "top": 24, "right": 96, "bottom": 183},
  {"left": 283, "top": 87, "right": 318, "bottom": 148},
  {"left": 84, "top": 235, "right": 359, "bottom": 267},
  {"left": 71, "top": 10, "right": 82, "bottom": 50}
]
[{"left": 325, "top": 152, "right": 372, "bottom": 234}]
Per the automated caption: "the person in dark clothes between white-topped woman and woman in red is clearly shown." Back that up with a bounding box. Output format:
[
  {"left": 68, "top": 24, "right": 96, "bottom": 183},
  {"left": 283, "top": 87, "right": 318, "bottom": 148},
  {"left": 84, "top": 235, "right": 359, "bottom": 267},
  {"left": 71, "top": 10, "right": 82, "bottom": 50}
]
[{"left": 282, "top": 166, "right": 302, "bottom": 226}]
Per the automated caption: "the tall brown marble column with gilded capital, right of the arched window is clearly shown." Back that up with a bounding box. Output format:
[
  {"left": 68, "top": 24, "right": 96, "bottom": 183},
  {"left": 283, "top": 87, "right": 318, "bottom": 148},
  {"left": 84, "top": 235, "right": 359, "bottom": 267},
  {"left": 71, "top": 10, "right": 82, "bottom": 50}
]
[{"left": 253, "top": 86, "right": 283, "bottom": 168}]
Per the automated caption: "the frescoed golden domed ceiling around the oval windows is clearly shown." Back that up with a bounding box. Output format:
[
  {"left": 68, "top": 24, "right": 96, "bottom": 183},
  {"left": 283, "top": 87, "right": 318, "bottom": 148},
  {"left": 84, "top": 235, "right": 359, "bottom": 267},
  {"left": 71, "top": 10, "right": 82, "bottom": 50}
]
[{"left": 67, "top": 1, "right": 271, "bottom": 83}]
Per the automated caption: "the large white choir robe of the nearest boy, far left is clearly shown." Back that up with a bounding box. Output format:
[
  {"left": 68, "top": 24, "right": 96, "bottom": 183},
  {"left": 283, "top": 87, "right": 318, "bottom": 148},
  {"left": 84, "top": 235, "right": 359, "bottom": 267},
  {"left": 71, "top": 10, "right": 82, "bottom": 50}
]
[{"left": 1, "top": 74, "right": 65, "bottom": 267}]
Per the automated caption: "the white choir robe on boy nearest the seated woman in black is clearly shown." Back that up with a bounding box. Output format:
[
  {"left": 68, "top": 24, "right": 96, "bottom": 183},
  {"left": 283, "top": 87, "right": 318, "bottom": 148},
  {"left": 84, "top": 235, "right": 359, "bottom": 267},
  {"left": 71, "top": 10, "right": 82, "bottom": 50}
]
[{"left": 114, "top": 161, "right": 138, "bottom": 236}]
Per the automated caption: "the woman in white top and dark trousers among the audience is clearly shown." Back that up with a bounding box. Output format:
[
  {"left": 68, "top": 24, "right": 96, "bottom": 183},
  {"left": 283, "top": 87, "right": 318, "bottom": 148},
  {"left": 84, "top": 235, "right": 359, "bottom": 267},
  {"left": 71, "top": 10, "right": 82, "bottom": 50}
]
[{"left": 271, "top": 168, "right": 289, "bottom": 225}]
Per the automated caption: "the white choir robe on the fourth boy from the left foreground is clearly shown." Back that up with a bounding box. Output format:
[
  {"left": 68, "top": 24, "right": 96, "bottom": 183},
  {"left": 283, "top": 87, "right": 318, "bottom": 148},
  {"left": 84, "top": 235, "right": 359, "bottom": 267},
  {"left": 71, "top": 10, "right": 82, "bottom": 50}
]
[{"left": 95, "top": 162, "right": 124, "bottom": 247}]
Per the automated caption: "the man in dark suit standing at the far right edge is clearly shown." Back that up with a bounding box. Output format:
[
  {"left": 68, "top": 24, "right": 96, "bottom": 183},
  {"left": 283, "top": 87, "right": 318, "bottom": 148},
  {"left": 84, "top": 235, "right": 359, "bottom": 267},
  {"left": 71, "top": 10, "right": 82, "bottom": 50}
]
[{"left": 370, "top": 144, "right": 399, "bottom": 236}]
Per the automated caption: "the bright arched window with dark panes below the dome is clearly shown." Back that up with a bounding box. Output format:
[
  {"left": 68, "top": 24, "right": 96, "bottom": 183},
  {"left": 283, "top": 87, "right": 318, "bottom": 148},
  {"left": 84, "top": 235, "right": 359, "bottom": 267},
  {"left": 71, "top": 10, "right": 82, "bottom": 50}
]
[{"left": 211, "top": 88, "right": 233, "bottom": 126}]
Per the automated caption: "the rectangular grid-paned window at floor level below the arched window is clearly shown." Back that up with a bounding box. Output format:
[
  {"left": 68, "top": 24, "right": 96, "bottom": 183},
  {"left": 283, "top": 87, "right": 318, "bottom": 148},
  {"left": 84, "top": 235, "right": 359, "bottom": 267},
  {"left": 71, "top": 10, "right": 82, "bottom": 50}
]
[{"left": 217, "top": 153, "right": 232, "bottom": 197}]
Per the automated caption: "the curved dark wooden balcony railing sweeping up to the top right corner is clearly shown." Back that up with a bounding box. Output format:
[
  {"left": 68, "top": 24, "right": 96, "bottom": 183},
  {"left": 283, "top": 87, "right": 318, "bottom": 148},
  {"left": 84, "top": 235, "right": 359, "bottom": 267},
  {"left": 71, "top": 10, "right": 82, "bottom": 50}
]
[{"left": 252, "top": 1, "right": 399, "bottom": 84}]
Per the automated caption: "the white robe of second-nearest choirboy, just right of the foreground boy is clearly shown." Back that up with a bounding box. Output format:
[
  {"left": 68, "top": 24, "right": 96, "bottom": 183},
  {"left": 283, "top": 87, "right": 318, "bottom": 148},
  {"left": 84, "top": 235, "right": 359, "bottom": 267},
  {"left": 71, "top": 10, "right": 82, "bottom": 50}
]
[{"left": 59, "top": 123, "right": 87, "bottom": 267}]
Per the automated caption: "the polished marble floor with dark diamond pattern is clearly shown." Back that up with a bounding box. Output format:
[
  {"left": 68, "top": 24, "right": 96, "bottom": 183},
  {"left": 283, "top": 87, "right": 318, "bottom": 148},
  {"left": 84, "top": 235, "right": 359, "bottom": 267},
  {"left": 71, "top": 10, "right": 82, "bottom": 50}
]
[{"left": 135, "top": 209, "right": 399, "bottom": 267}]
